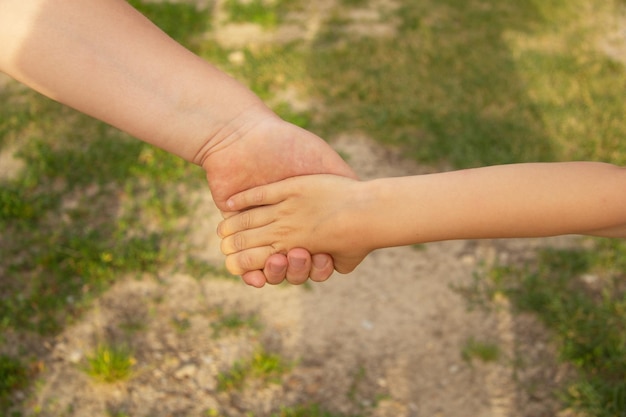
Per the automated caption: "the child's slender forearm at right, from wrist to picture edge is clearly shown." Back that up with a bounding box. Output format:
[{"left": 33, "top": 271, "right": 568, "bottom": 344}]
[{"left": 368, "top": 162, "right": 626, "bottom": 247}]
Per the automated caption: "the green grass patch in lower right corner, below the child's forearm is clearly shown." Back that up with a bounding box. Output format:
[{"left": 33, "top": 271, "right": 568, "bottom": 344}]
[{"left": 476, "top": 239, "right": 626, "bottom": 417}]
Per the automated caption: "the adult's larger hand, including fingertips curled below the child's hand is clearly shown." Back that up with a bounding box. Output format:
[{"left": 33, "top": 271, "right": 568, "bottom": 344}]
[{"left": 201, "top": 117, "right": 356, "bottom": 288}]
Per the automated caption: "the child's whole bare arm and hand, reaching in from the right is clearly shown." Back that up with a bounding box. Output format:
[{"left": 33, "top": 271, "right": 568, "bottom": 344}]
[{"left": 218, "top": 162, "right": 626, "bottom": 273}]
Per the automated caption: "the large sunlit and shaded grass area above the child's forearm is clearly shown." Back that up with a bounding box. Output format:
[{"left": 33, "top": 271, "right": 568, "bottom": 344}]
[{"left": 307, "top": 0, "right": 626, "bottom": 167}]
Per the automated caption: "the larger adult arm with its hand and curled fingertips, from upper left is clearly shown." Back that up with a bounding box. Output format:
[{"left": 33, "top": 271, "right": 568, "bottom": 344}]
[{"left": 0, "top": 0, "right": 355, "bottom": 287}]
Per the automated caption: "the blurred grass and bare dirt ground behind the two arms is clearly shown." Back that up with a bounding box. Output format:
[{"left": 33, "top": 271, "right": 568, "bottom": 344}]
[{"left": 0, "top": 0, "right": 626, "bottom": 417}]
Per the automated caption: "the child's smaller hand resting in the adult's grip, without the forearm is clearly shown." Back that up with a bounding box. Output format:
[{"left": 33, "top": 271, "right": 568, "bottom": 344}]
[{"left": 218, "top": 175, "right": 372, "bottom": 283}]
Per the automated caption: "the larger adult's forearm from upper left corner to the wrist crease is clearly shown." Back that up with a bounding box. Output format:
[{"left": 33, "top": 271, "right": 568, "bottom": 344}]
[{"left": 0, "top": 0, "right": 273, "bottom": 164}]
